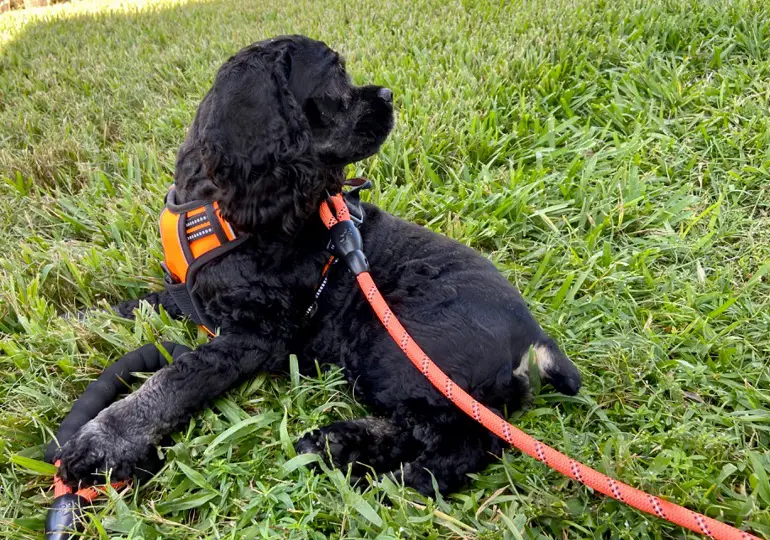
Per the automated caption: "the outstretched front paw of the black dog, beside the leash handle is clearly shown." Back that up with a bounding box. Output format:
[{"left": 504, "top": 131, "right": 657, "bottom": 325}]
[{"left": 57, "top": 418, "right": 151, "bottom": 487}]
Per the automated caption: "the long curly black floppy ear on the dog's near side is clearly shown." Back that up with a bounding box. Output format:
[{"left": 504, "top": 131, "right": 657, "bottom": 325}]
[{"left": 194, "top": 46, "right": 324, "bottom": 234}]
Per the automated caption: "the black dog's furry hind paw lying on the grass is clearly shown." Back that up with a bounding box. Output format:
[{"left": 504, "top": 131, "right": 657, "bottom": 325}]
[{"left": 295, "top": 417, "right": 424, "bottom": 479}]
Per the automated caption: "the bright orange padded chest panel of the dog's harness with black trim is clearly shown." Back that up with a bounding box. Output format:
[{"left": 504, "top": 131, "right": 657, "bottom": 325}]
[{"left": 160, "top": 186, "right": 249, "bottom": 336}]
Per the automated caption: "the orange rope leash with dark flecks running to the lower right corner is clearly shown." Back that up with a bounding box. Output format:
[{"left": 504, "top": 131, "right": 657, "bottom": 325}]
[{"left": 320, "top": 195, "right": 758, "bottom": 540}]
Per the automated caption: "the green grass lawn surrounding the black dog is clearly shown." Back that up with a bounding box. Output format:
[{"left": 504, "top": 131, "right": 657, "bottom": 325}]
[{"left": 0, "top": 0, "right": 770, "bottom": 539}]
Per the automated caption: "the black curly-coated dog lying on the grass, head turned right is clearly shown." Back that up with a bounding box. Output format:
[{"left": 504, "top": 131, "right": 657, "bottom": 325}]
[{"left": 60, "top": 36, "right": 580, "bottom": 494}]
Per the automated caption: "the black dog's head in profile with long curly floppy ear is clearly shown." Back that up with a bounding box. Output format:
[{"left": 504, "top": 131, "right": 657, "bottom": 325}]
[{"left": 175, "top": 36, "right": 393, "bottom": 235}]
